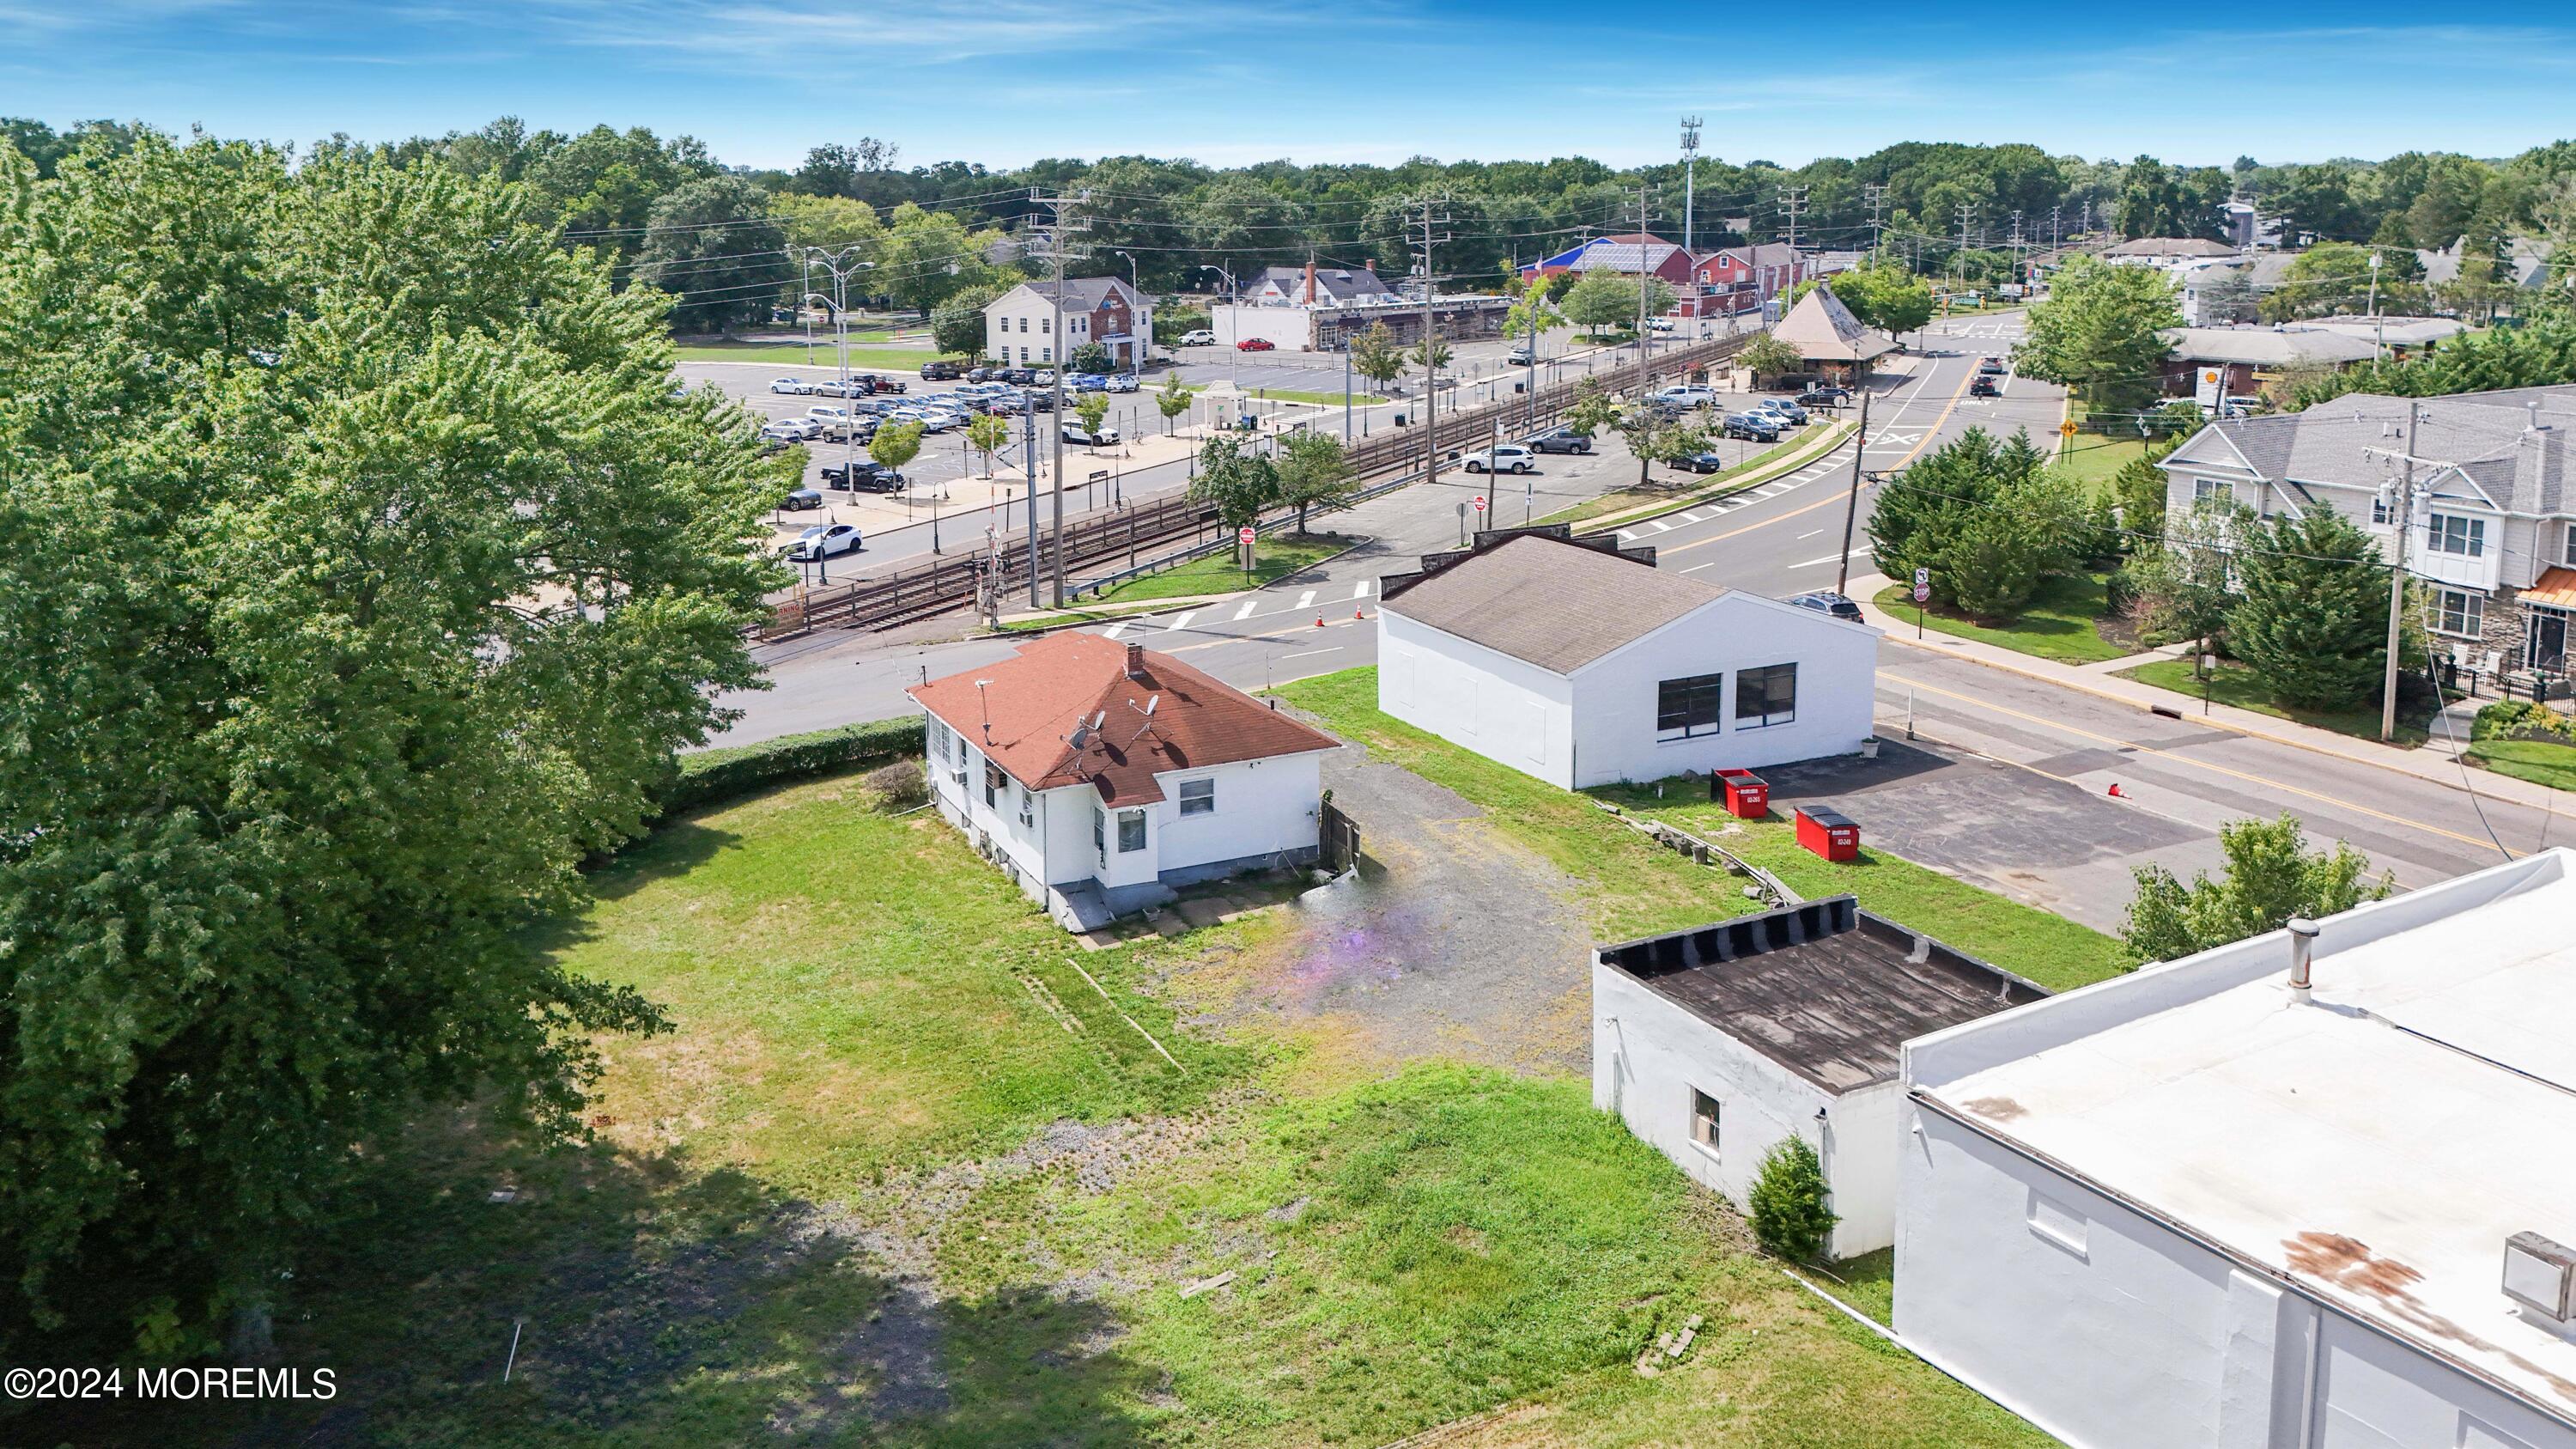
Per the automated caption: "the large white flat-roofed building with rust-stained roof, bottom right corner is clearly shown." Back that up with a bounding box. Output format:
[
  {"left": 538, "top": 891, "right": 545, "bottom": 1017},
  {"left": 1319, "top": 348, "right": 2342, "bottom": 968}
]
[{"left": 1896, "top": 851, "right": 2576, "bottom": 1449}]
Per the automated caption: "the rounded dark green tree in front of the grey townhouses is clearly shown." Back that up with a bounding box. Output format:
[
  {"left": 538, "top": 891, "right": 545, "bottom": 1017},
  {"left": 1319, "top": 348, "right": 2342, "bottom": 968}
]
[{"left": 2228, "top": 505, "right": 2388, "bottom": 709}]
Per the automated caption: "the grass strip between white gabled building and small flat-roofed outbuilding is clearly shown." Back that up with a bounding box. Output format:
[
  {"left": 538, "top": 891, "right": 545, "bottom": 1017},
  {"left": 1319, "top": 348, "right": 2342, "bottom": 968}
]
[{"left": 1278, "top": 667, "right": 2128, "bottom": 990}]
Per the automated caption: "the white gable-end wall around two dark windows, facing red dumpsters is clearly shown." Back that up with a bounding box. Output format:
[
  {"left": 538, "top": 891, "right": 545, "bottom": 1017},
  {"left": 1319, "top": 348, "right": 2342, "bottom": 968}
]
[{"left": 1571, "top": 595, "right": 1878, "bottom": 789}]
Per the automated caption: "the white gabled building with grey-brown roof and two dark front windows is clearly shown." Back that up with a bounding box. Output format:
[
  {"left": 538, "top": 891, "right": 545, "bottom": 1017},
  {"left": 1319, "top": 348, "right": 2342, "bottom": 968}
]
[{"left": 1378, "top": 526, "right": 1878, "bottom": 789}]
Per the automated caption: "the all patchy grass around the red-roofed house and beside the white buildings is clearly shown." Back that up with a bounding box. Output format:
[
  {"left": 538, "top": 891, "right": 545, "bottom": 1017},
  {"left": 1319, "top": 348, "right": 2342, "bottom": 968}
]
[{"left": 131, "top": 696, "right": 2071, "bottom": 1449}]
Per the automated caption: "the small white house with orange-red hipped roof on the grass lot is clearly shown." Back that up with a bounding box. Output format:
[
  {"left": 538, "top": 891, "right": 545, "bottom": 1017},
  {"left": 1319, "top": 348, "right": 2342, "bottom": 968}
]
[{"left": 907, "top": 631, "right": 1340, "bottom": 931}]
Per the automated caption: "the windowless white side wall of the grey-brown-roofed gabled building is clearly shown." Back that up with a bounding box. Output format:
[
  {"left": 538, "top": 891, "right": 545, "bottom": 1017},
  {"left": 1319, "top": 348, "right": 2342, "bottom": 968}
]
[{"left": 1378, "top": 608, "right": 1577, "bottom": 789}]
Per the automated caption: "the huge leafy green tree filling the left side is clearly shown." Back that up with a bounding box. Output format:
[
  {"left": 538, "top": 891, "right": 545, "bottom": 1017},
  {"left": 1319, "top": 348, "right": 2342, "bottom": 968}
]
[{"left": 0, "top": 131, "right": 793, "bottom": 1356}]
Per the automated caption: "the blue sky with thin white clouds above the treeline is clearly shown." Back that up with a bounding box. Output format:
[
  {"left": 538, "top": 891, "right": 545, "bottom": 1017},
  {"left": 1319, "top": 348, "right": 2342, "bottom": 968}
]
[{"left": 0, "top": 0, "right": 2576, "bottom": 165}]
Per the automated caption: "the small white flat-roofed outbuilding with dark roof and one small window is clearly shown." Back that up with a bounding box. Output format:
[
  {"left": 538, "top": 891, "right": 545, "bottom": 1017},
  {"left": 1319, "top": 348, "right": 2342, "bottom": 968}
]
[{"left": 1592, "top": 895, "right": 2048, "bottom": 1258}]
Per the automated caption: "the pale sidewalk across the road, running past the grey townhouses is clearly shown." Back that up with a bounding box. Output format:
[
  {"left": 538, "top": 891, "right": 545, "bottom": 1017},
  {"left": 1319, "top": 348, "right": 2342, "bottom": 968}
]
[{"left": 1852, "top": 572, "right": 2568, "bottom": 810}]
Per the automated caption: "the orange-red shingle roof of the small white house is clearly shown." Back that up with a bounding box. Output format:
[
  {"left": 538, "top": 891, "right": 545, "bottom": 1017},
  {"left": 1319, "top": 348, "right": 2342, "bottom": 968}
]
[{"left": 904, "top": 631, "right": 1340, "bottom": 805}]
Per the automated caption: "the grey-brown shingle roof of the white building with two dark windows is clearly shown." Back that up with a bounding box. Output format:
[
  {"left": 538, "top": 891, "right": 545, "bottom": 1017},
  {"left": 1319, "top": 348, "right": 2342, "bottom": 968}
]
[{"left": 1381, "top": 533, "right": 1726, "bottom": 673}]
